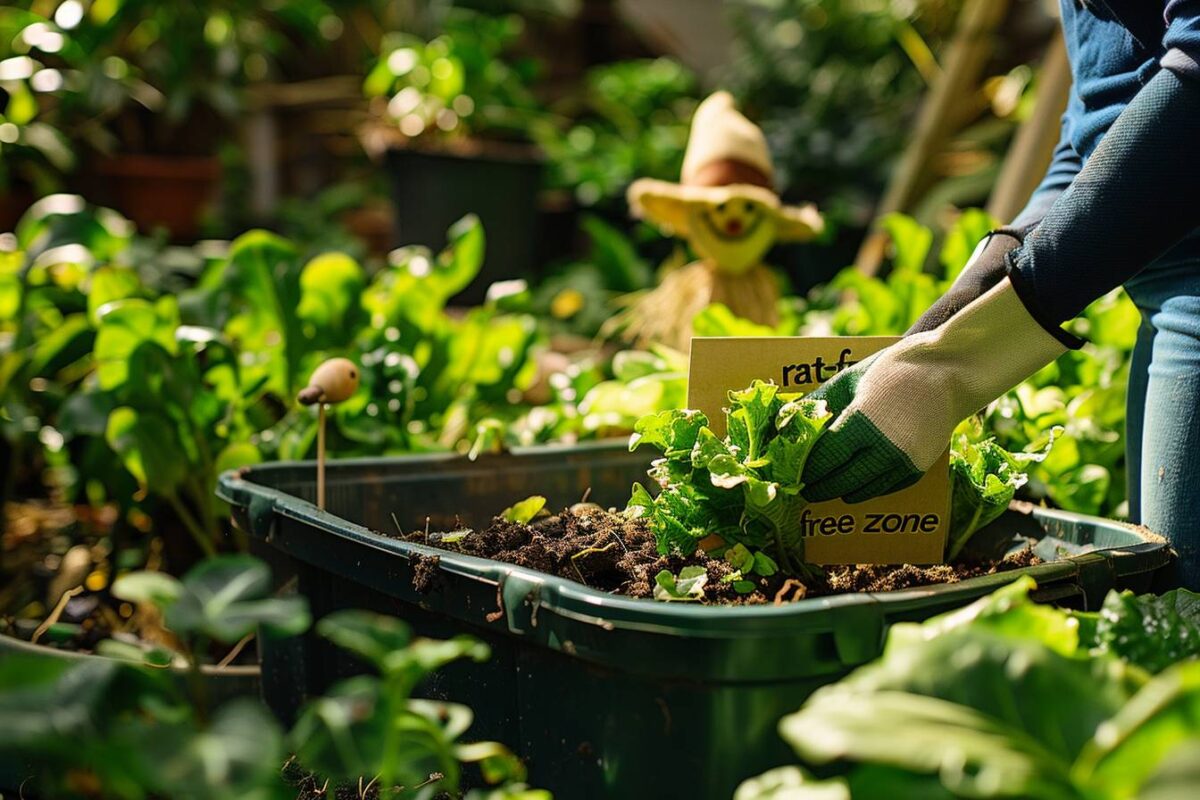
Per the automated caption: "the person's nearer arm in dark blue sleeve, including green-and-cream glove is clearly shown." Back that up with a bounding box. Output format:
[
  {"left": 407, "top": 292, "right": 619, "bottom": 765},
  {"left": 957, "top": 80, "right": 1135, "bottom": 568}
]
[{"left": 804, "top": 35, "right": 1200, "bottom": 503}]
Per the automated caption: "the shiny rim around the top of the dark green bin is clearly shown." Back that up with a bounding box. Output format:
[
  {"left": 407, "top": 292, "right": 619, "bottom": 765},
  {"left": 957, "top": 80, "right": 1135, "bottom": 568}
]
[{"left": 216, "top": 441, "right": 1168, "bottom": 637}]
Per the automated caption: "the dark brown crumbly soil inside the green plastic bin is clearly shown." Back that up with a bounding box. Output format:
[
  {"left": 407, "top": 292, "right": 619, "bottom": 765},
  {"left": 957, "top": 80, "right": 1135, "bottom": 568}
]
[{"left": 400, "top": 503, "right": 1039, "bottom": 604}]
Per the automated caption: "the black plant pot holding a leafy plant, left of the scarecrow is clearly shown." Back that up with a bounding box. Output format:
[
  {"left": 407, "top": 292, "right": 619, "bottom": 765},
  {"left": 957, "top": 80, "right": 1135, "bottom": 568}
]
[{"left": 384, "top": 148, "right": 541, "bottom": 303}]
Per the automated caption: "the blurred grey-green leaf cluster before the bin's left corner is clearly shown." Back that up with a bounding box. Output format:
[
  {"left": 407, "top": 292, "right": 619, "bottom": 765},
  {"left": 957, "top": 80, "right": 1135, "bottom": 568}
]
[{"left": 166, "top": 555, "right": 311, "bottom": 644}]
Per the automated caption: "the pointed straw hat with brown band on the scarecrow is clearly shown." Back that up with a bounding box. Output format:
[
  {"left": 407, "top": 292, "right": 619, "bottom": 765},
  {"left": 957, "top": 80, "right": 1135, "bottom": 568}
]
[{"left": 628, "top": 91, "right": 824, "bottom": 241}]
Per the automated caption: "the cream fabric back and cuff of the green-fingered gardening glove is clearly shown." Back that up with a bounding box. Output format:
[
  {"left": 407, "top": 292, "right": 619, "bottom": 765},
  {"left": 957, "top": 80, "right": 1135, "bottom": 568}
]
[{"left": 846, "top": 277, "right": 1067, "bottom": 471}]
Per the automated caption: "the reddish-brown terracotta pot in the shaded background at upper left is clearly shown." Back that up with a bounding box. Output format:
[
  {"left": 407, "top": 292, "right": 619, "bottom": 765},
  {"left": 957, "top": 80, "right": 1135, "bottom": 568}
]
[{"left": 96, "top": 155, "right": 221, "bottom": 241}]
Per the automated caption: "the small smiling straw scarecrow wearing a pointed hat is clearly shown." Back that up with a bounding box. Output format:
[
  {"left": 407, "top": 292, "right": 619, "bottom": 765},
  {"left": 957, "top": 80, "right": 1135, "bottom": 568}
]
[{"left": 622, "top": 91, "right": 823, "bottom": 353}]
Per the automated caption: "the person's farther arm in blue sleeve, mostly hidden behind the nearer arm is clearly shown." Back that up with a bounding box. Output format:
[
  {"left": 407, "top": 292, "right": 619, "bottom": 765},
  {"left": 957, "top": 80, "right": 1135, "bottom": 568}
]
[{"left": 906, "top": 92, "right": 1084, "bottom": 335}]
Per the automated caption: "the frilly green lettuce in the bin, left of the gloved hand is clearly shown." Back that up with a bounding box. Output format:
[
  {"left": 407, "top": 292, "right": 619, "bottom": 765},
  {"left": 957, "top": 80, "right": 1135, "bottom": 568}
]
[{"left": 626, "top": 381, "right": 829, "bottom": 582}]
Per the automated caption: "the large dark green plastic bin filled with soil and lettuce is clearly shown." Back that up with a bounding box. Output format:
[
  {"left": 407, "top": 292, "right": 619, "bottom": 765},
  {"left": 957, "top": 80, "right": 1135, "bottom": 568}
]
[{"left": 218, "top": 445, "right": 1170, "bottom": 800}]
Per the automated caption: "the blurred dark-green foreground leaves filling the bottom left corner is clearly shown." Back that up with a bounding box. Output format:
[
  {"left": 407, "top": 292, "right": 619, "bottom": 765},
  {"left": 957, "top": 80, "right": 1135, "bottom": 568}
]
[{"left": 0, "top": 557, "right": 550, "bottom": 800}]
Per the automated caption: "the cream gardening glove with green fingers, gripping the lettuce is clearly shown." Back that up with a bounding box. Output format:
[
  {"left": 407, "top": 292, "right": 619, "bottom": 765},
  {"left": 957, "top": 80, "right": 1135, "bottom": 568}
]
[{"left": 803, "top": 277, "right": 1067, "bottom": 503}]
